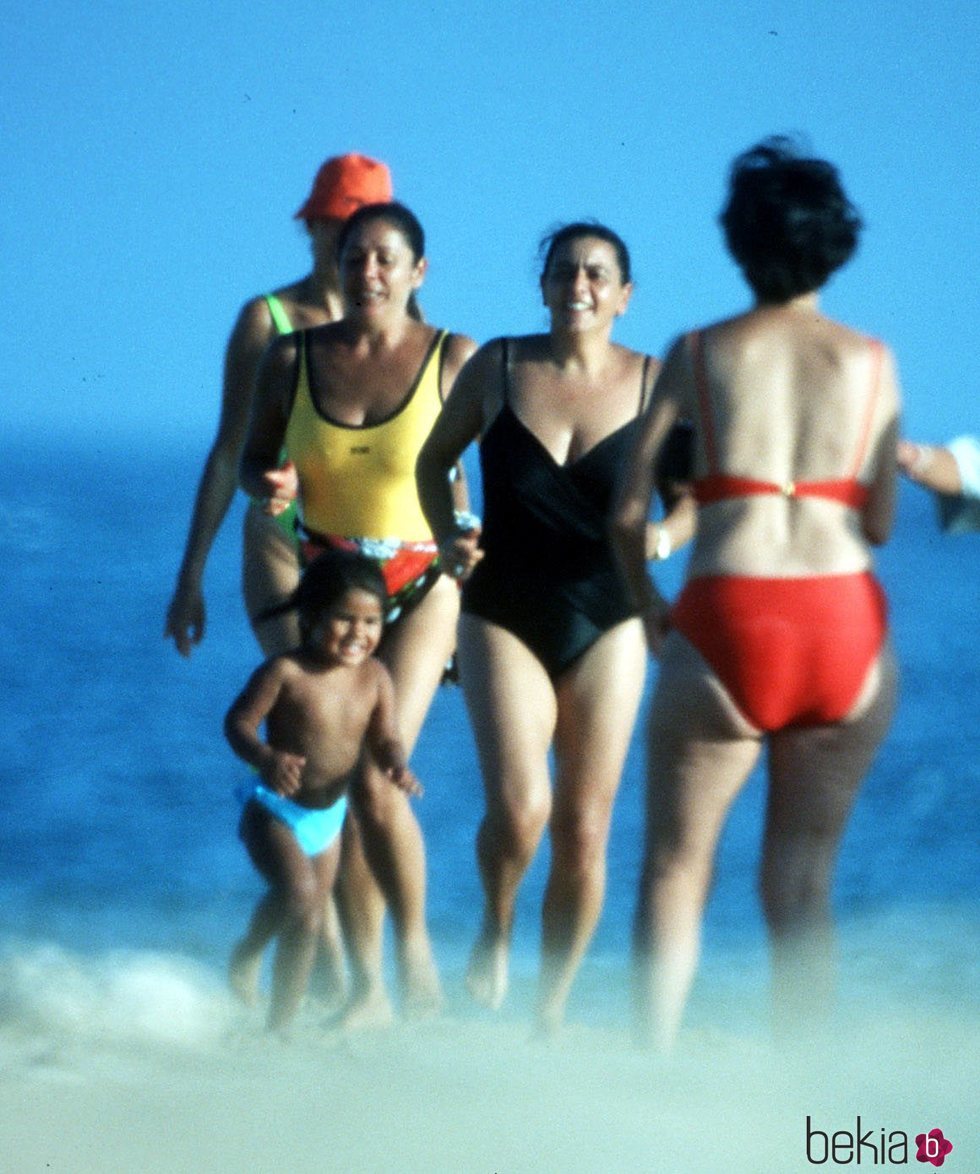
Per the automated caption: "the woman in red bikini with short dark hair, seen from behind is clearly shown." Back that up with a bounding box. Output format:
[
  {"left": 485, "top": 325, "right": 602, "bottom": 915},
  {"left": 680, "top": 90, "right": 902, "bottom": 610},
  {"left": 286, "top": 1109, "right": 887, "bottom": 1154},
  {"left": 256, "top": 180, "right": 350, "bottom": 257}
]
[{"left": 615, "top": 139, "right": 899, "bottom": 1050}]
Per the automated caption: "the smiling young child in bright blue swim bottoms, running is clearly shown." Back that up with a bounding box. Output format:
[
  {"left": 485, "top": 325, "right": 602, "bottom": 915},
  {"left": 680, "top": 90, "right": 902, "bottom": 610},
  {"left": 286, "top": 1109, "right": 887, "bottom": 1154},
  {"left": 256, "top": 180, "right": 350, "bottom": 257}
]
[{"left": 224, "top": 551, "right": 421, "bottom": 1032}]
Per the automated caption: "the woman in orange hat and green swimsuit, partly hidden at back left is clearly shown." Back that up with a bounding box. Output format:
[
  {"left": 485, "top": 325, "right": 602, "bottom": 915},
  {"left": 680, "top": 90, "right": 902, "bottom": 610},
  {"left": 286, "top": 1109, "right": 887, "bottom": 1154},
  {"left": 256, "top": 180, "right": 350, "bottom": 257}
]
[{"left": 164, "top": 155, "right": 392, "bottom": 998}]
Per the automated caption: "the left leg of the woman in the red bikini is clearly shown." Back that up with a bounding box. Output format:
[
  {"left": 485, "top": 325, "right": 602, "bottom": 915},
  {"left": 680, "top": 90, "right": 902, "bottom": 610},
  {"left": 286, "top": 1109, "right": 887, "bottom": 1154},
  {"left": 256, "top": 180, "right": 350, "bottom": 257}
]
[{"left": 634, "top": 633, "right": 761, "bottom": 1051}]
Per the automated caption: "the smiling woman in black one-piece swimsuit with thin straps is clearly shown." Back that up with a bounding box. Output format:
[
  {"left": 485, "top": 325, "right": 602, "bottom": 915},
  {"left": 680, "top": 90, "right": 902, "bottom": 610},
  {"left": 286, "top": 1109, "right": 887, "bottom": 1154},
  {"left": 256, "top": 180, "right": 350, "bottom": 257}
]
[{"left": 418, "top": 223, "right": 676, "bottom": 1031}]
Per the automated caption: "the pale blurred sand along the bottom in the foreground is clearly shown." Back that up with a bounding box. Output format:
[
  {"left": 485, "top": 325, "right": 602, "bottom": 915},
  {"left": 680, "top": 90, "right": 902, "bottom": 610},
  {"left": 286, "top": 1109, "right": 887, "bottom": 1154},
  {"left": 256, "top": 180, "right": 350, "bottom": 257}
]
[{"left": 0, "top": 956, "right": 980, "bottom": 1174}]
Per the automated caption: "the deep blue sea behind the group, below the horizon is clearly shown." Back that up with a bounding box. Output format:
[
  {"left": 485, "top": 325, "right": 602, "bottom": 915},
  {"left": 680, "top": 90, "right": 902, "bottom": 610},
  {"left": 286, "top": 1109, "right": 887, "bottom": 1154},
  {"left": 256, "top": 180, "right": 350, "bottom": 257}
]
[{"left": 0, "top": 443, "right": 980, "bottom": 1019}]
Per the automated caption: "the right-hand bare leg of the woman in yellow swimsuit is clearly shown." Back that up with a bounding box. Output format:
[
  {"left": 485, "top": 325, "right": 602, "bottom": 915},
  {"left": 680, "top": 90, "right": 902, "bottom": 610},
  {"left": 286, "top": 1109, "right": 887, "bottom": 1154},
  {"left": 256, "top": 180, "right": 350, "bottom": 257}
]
[{"left": 345, "top": 576, "right": 459, "bottom": 1018}]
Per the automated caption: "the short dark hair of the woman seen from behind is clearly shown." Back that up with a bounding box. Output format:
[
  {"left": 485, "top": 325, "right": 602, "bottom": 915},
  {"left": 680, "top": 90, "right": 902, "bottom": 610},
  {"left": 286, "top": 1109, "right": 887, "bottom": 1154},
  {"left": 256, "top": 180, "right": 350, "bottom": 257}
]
[{"left": 719, "top": 136, "right": 863, "bottom": 302}]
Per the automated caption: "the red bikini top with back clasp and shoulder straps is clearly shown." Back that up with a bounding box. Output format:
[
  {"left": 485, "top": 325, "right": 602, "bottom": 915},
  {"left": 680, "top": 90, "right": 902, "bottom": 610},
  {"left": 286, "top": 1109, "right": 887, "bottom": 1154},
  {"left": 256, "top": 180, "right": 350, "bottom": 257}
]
[{"left": 688, "top": 330, "right": 883, "bottom": 510}]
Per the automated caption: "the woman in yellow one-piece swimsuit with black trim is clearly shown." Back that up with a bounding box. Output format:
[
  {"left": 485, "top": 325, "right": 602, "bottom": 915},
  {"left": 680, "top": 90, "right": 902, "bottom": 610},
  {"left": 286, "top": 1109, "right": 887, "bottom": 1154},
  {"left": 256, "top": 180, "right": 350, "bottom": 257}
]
[{"left": 242, "top": 203, "right": 475, "bottom": 1025}]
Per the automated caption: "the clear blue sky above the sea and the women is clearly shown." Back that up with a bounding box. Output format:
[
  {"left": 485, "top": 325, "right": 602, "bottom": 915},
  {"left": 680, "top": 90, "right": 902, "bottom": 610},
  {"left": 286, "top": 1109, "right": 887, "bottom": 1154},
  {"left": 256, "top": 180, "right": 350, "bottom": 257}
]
[{"left": 0, "top": 0, "right": 980, "bottom": 448}]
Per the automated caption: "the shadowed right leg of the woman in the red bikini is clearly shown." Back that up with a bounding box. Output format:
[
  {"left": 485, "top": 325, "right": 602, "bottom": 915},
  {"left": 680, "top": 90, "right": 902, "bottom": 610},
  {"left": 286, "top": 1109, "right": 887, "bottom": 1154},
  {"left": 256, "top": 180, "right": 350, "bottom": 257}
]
[{"left": 761, "top": 648, "right": 897, "bottom": 1034}]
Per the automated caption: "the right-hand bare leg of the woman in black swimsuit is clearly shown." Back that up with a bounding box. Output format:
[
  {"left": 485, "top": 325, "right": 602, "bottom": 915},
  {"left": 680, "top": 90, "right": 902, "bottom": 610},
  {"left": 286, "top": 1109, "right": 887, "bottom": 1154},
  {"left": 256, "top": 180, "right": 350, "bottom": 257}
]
[{"left": 538, "top": 620, "right": 647, "bottom": 1032}]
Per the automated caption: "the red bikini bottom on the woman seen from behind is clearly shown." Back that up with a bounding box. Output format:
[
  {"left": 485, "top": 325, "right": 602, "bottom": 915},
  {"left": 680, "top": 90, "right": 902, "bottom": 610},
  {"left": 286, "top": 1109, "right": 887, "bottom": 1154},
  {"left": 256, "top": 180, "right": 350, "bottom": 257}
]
[{"left": 671, "top": 572, "right": 887, "bottom": 731}]
